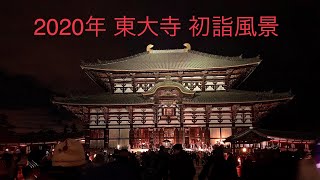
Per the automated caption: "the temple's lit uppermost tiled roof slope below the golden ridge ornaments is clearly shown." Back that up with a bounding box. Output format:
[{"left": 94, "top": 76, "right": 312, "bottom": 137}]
[{"left": 81, "top": 45, "right": 261, "bottom": 71}]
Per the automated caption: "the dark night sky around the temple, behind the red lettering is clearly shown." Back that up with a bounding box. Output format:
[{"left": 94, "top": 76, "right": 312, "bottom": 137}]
[{"left": 0, "top": 0, "right": 320, "bottom": 131}]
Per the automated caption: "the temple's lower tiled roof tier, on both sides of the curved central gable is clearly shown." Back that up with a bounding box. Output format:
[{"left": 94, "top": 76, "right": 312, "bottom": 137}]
[{"left": 54, "top": 90, "right": 292, "bottom": 105}]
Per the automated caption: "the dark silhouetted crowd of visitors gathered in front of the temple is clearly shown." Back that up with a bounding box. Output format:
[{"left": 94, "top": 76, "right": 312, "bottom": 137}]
[{"left": 0, "top": 139, "right": 316, "bottom": 180}]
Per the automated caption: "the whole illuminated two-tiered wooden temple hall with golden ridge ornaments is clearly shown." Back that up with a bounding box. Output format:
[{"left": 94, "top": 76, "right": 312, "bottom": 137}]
[{"left": 54, "top": 43, "right": 292, "bottom": 149}]
